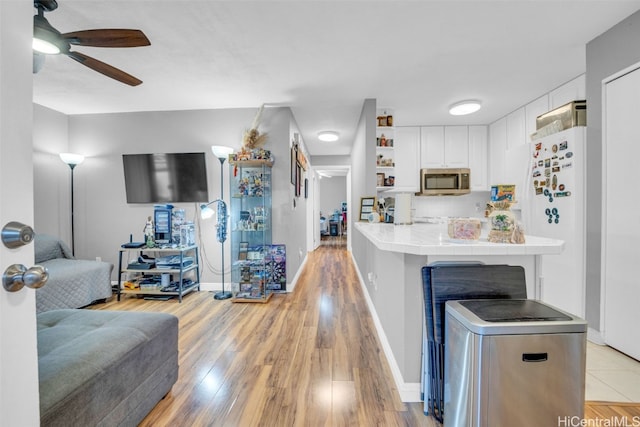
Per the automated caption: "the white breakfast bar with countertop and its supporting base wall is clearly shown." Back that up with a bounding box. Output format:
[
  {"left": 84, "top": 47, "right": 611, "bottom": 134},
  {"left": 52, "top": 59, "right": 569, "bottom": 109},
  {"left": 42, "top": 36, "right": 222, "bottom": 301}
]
[{"left": 352, "top": 222, "right": 564, "bottom": 402}]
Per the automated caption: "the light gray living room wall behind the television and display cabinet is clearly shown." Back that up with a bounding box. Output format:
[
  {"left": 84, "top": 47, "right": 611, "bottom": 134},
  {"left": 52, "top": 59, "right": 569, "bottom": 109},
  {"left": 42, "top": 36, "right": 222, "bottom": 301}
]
[{"left": 34, "top": 106, "right": 307, "bottom": 290}]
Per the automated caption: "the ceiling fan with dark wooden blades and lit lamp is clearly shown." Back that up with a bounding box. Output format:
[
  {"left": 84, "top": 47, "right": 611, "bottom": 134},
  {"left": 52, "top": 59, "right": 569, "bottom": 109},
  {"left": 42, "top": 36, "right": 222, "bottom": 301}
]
[{"left": 33, "top": 0, "right": 151, "bottom": 86}]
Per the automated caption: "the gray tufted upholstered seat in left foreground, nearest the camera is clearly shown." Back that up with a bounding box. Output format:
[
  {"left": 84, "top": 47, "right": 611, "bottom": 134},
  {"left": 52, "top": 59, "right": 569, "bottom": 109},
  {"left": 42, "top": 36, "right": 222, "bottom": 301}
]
[{"left": 37, "top": 309, "right": 178, "bottom": 427}]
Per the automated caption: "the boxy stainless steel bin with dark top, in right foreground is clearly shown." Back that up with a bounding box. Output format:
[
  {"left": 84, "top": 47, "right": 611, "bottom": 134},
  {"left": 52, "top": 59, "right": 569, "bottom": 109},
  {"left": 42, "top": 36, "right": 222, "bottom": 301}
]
[{"left": 444, "top": 299, "right": 587, "bottom": 427}]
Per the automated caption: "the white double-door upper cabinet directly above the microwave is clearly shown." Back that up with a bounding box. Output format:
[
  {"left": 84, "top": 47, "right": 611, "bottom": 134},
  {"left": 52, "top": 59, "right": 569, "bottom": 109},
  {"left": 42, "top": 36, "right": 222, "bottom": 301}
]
[{"left": 420, "top": 126, "right": 469, "bottom": 168}]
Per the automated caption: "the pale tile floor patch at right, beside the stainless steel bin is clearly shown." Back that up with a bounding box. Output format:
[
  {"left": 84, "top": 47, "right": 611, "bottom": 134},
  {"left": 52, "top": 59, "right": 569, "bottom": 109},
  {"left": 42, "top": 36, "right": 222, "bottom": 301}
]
[{"left": 585, "top": 341, "right": 640, "bottom": 402}]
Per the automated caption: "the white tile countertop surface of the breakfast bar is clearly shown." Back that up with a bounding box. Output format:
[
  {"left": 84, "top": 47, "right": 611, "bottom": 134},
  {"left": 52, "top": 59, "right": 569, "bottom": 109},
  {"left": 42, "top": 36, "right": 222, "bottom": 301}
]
[{"left": 354, "top": 222, "right": 564, "bottom": 255}]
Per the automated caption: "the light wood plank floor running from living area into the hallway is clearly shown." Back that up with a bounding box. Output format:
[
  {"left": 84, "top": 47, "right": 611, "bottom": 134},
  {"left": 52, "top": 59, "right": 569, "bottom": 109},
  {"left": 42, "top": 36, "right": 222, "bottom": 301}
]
[{"left": 91, "top": 246, "right": 640, "bottom": 427}]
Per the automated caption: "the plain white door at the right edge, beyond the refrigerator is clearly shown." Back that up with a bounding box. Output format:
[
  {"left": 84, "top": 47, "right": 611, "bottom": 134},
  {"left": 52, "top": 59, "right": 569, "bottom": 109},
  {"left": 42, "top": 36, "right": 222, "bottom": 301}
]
[{"left": 603, "top": 69, "right": 640, "bottom": 359}]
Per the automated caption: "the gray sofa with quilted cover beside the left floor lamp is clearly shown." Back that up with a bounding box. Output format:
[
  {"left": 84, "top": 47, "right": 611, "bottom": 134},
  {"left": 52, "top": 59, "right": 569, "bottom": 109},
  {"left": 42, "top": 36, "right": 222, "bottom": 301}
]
[{"left": 34, "top": 234, "right": 113, "bottom": 313}]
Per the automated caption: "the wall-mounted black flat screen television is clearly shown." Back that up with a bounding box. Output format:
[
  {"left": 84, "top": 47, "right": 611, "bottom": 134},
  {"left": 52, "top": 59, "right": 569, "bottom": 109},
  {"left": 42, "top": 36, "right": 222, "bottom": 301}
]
[{"left": 122, "top": 153, "right": 209, "bottom": 203}]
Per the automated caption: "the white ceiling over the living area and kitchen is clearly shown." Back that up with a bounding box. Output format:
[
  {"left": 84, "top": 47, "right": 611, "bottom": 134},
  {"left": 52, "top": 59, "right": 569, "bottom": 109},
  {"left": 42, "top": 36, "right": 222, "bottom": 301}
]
[{"left": 33, "top": 0, "right": 640, "bottom": 159}]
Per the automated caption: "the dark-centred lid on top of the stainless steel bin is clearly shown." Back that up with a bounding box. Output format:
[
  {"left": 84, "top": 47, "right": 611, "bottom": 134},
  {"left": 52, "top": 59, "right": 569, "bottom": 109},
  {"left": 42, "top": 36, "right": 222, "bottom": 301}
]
[{"left": 446, "top": 299, "right": 587, "bottom": 335}]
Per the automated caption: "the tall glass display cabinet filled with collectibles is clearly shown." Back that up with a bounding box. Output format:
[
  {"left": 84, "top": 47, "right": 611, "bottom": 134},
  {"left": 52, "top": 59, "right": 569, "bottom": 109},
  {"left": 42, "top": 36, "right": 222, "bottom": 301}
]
[{"left": 229, "top": 160, "right": 273, "bottom": 302}]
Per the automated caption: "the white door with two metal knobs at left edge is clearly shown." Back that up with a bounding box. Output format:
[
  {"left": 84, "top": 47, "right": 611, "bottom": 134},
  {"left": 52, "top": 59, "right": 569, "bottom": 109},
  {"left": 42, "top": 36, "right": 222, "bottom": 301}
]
[{"left": 0, "top": 1, "right": 40, "bottom": 426}]
